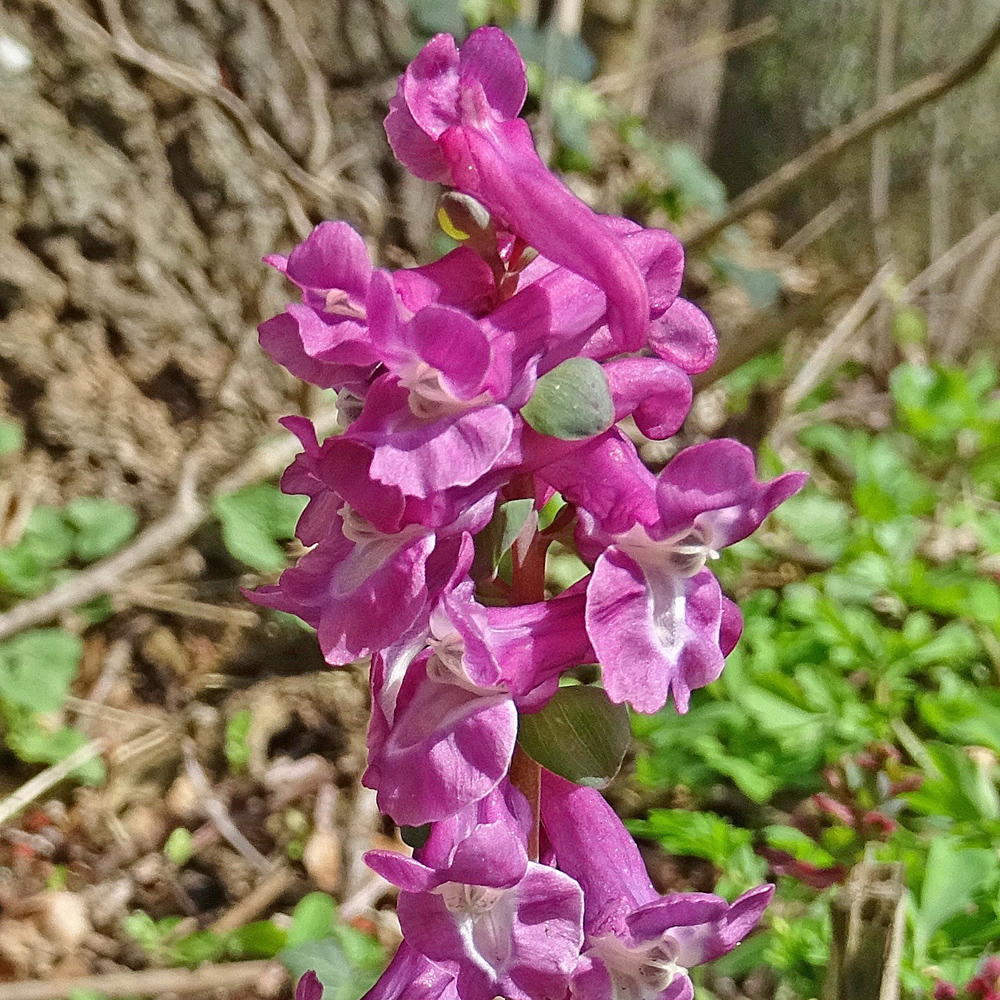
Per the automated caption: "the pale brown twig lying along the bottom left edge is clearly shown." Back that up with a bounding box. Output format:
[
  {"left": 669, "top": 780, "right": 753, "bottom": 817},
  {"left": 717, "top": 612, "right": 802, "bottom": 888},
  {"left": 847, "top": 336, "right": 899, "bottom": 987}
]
[{"left": 0, "top": 961, "right": 281, "bottom": 1000}]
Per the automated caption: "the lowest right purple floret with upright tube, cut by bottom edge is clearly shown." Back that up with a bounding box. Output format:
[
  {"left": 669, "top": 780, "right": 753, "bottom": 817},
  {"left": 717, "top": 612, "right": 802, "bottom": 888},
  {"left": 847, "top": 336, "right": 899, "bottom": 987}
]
[{"left": 542, "top": 772, "right": 774, "bottom": 1000}]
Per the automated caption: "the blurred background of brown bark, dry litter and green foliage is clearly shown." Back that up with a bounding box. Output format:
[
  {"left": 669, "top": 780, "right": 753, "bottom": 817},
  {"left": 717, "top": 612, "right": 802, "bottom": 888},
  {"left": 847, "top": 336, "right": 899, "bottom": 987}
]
[{"left": 0, "top": 0, "right": 1000, "bottom": 1000}]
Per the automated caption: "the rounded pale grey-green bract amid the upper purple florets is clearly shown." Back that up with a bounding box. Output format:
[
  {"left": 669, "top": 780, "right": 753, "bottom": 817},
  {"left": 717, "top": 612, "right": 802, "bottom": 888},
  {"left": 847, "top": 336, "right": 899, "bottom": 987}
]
[{"left": 521, "top": 358, "right": 615, "bottom": 441}]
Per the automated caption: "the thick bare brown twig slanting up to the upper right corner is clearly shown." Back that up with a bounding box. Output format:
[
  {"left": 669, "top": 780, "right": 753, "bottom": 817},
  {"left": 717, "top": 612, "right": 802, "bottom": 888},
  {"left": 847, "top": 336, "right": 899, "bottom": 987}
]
[{"left": 685, "top": 10, "right": 1000, "bottom": 250}]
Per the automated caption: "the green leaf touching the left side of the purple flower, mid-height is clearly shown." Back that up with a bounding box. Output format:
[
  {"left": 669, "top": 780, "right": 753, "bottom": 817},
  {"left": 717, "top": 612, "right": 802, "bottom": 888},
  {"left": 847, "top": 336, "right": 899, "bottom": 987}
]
[{"left": 214, "top": 483, "right": 306, "bottom": 573}]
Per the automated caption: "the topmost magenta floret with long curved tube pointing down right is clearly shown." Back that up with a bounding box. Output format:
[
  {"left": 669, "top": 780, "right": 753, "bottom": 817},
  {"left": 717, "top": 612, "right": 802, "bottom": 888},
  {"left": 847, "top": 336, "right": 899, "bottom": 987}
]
[{"left": 385, "top": 27, "right": 649, "bottom": 350}]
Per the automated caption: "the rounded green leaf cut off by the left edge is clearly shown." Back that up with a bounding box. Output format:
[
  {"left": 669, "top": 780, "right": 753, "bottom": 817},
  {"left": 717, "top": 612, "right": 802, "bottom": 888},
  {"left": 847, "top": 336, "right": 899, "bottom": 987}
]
[{"left": 0, "top": 628, "right": 83, "bottom": 712}]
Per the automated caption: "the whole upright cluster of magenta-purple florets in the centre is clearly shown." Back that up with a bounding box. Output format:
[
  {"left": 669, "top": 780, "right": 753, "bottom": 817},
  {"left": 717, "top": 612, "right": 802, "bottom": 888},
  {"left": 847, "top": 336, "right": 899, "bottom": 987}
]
[{"left": 252, "top": 28, "right": 803, "bottom": 1000}]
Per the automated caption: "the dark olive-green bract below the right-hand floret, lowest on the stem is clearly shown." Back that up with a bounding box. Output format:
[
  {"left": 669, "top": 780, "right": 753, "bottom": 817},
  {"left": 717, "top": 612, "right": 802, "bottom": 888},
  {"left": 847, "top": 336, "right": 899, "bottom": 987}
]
[{"left": 518, "top": 686, "right": 631, "bottom": 788}]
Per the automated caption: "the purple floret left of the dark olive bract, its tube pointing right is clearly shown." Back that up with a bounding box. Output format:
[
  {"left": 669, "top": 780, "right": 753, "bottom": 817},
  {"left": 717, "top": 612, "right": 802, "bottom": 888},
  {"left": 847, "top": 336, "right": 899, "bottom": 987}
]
[{"left": 363, "top": 581, "right": 593, "bottom": 826}]
